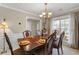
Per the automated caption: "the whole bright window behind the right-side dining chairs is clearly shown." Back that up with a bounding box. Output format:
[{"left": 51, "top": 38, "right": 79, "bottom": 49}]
[{"left": 52, "top": 18, "right": 70, "bottom": 41}]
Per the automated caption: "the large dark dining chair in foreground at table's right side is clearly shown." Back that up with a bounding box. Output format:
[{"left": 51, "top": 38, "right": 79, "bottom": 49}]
[{"left": 33, "top": 31, "right": 54, "bottom": 55}]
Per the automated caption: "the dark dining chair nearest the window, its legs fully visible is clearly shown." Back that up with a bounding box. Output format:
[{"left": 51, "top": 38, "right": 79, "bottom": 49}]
[{"left": 52, "top": 31, "right": 65, "bottom": 55}]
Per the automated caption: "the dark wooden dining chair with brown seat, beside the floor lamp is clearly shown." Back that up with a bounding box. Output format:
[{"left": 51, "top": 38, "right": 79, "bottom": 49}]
[{"left": 4, "top": 33, "right": 25, "bottom": 55}]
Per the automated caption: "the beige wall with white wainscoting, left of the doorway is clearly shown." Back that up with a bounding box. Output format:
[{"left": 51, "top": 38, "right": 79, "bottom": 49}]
[{"left": 0, "top": 6, "right": 38, "bottom": 53}]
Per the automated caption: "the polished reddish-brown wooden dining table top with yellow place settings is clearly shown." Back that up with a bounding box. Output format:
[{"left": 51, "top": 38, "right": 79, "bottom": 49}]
[{"left": 18, "top": 36, "right": 47, "bottom": 52}]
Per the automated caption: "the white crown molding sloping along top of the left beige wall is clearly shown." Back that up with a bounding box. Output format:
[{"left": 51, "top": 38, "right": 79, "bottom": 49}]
[{"left": 0, "top": 3, "right": 39, "bottom": 18}]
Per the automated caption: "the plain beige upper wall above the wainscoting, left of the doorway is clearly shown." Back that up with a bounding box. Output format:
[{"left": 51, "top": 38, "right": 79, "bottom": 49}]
[{"left": 0, "top": 7, "right": 26, "bottom": 33}]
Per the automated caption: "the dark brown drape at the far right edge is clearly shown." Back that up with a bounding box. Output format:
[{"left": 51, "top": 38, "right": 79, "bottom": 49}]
[{"left": 73, "top": 12, "right": 79, "bottom": 49}]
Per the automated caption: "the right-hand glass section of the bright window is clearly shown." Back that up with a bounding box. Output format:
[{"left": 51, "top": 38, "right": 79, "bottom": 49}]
[{"left": 60, "top": 18, "right": 70, "bottom": 39}]
